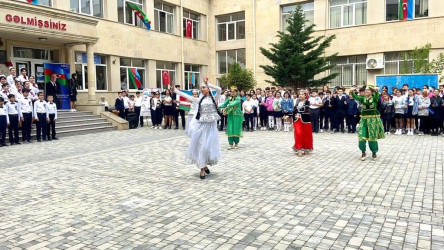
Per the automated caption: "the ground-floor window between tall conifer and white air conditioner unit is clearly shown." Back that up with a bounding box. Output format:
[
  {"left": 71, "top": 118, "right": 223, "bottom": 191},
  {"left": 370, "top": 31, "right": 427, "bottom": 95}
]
[{"left": 330, "top": 55, "right": 367, "bottom": 87}]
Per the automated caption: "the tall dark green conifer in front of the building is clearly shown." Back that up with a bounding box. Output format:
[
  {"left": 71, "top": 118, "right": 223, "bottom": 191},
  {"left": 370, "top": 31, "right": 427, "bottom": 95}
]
[{"left": 260, "top": 6, "right": 338, "bottom": 89}]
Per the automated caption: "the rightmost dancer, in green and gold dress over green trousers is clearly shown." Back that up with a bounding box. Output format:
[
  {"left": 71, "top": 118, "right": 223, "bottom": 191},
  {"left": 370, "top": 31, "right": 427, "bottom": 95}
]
[{"left": 352, "top": 92, "right": 385, "bottom": 153}]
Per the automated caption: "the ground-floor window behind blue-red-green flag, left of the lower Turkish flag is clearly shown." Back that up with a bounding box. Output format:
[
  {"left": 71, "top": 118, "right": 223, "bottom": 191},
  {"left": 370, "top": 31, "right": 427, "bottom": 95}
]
[{"left": 120, "top": 58, "right": 145, "bottom": 89}]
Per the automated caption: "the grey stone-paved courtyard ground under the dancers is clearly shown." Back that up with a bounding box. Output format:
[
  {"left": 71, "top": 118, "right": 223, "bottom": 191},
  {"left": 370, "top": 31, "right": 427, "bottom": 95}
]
[{"left": 0, "top": 128, "right": 444, "bottom": 249}]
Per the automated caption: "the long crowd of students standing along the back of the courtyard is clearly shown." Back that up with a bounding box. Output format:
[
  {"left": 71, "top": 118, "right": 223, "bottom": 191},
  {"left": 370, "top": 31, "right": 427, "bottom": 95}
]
[{"left": 116, "top": 84, "right": 444, "bottom": 136}]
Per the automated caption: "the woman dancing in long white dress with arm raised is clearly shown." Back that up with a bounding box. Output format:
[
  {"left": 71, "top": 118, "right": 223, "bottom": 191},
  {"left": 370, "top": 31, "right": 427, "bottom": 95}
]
[{"left": 185, "top": 78, "right": 221, "bottom": 179}]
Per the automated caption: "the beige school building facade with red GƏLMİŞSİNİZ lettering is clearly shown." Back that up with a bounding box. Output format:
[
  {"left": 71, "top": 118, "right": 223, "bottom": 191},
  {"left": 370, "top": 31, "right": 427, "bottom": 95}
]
[{"left": 0, "top": 0, "right": 444, "bottom": 103}]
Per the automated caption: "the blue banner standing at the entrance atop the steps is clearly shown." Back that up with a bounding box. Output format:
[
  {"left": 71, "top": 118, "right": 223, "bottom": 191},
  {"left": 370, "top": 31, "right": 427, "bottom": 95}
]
[{"left": 43, "top": 63, "right": 71, "bottom": 109}]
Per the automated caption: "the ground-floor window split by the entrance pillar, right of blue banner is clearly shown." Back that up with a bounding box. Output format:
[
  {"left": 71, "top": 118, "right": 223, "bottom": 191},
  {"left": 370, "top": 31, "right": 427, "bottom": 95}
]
[{"left": 75, "top": 52, "right": 108, "bottom": 90}]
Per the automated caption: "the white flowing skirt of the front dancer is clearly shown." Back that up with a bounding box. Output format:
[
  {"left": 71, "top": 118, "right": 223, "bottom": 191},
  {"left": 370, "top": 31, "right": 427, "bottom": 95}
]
[{"left": 185, "top": 118, "right": 221, "bottom": 168}]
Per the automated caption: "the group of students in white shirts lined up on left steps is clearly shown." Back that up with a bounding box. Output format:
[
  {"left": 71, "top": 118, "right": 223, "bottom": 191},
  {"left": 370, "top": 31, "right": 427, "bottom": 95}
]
[{"left": 0, "top": 67, "right": 58, "bottom": 147}]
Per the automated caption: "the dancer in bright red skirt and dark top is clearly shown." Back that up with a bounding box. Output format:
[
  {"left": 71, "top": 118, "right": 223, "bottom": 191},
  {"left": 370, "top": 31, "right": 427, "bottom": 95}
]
[{"left": 293, "top": 93, "right": 313, "bottom": 157}]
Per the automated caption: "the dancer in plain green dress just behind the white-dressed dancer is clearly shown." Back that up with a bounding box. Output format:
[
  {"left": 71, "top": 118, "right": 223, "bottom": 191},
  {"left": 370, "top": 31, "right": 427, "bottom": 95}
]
[{"left": 219, "top": 96, "right": 244, "bottom": 145}]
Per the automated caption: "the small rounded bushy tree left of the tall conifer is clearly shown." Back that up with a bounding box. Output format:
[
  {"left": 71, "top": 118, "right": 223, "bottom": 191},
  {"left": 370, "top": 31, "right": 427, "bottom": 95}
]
[{"left": 220, "top": 63, "right": 256, "bottom": 91}]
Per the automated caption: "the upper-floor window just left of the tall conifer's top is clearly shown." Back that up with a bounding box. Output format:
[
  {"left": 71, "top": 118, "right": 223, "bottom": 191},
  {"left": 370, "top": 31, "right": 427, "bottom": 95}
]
[{"left": 217, "top": 12, "right": 245, "bottom": 42}]
